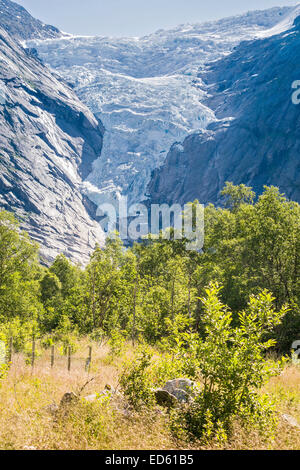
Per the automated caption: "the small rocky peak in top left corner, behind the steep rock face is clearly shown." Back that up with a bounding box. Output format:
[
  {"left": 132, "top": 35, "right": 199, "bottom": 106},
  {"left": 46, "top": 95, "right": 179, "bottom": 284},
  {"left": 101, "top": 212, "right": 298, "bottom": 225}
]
[{"left": 0, "top": 0, "right": 62, "bottom": 40}]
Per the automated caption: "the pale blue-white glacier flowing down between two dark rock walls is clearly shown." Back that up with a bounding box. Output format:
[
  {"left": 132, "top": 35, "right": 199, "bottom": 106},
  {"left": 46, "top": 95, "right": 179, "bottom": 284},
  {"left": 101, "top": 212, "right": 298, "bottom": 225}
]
[{"left": 27, "top": 8, "right": 292, "bottom": 204}]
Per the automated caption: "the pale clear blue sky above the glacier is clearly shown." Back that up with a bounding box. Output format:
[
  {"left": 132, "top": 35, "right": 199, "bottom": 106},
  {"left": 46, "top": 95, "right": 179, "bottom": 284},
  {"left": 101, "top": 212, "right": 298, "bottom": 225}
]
[{"left": 16, "top": 0, "right": 299, "bottom": 37}]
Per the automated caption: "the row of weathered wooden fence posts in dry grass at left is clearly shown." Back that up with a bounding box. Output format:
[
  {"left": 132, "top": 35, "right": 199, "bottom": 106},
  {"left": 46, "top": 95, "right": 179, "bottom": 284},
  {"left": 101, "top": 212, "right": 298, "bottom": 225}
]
[{"left": 3, "top": 337, "right": 93, "bottom": 372}]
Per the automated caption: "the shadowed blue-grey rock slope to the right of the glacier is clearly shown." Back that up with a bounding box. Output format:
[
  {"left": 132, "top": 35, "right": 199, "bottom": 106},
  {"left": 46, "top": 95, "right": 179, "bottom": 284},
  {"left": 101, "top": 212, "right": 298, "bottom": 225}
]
[{"left": 148, "top": 7, "right": 300, "bottom": 203}]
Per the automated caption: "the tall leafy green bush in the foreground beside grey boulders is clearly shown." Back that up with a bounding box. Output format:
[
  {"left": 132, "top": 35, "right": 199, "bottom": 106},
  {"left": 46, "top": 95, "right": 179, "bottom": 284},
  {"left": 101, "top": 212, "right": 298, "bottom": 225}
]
[{"left": 172, "top": 284, "right": 287, "bottom": 439}]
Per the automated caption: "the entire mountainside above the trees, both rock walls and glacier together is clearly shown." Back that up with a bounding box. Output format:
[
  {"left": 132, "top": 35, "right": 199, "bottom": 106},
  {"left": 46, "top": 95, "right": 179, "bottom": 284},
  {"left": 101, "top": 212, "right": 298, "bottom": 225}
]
[{"left": 0, "top": 0, "right": 300, "bottom": 263}]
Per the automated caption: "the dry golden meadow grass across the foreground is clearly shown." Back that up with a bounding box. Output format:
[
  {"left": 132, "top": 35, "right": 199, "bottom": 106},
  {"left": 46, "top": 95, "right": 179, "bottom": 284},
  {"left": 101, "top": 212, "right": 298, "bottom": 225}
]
[{"left": 0, "top": 342, "right": 300, "bottom": 450}]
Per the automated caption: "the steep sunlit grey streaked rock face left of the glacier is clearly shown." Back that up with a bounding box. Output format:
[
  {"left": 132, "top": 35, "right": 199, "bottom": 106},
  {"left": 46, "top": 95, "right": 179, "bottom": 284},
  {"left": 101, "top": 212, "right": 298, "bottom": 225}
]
[{"left": 0, "top": 28, "right": 104, "bottom": 263}]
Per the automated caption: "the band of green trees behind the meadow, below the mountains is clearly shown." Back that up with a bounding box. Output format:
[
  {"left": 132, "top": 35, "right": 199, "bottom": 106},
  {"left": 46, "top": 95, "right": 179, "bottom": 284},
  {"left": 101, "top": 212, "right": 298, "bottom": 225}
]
[{"left": 0, "top": 183, "right": 300, "bottom": 354}]
